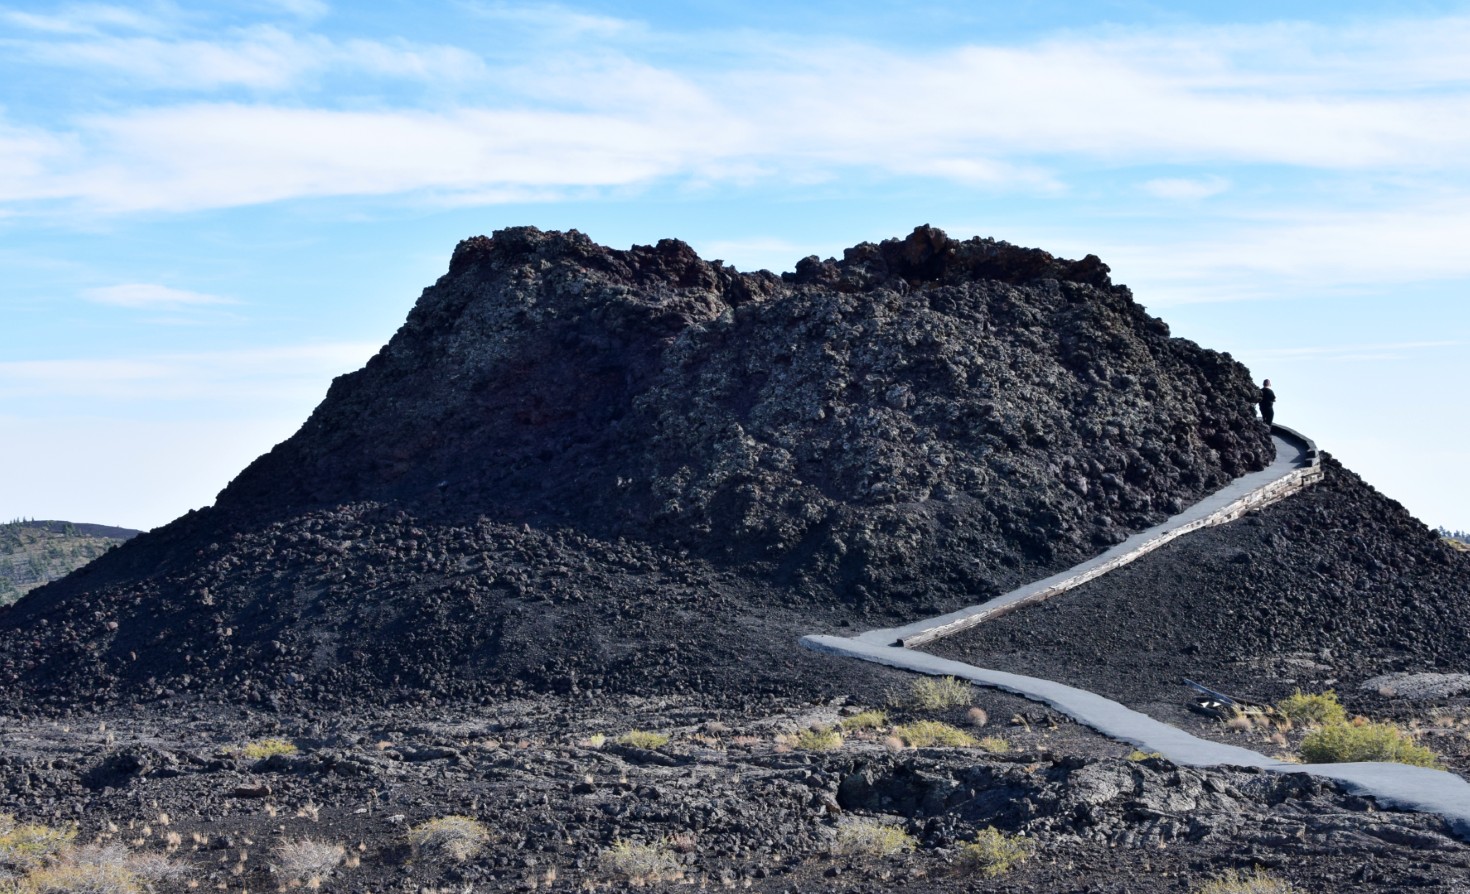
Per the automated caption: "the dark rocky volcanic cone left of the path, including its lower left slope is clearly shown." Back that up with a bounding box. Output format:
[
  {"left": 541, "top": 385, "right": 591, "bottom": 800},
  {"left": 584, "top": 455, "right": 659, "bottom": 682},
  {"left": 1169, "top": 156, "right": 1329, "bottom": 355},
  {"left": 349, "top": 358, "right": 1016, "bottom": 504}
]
[{"left": 0, "top": 226, "right": 1272, "bottom": 705}]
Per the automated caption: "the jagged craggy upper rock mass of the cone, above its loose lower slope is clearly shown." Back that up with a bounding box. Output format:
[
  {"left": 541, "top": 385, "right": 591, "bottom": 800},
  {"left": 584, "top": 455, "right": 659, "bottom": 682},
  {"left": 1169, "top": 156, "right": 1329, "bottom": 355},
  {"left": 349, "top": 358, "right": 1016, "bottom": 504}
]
[{"left": 221, "top": 228, "right": 1270, "bottom": 593}]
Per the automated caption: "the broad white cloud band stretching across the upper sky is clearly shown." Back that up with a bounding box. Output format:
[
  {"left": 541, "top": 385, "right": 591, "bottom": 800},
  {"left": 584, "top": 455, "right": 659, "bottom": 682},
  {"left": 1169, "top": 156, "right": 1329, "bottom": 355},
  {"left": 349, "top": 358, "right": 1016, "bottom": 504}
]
[{"left": 0, "top": 11, "right": 1470, "bottom": 213}]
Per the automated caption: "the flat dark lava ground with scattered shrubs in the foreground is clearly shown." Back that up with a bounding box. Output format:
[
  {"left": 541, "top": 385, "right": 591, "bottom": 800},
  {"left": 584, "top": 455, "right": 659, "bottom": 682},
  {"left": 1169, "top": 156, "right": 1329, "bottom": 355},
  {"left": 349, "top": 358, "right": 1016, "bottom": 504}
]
[{"left": 0, "top": 682, "right": 1470, "bottom": 894}]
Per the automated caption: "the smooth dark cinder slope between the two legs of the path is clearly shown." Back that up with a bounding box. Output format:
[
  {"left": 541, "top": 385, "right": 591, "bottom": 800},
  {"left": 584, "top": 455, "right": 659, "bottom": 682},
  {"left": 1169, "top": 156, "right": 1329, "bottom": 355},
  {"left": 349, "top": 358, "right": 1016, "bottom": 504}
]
[{"left": 926, "top": 456, "right": 1470, "bottom": 775}]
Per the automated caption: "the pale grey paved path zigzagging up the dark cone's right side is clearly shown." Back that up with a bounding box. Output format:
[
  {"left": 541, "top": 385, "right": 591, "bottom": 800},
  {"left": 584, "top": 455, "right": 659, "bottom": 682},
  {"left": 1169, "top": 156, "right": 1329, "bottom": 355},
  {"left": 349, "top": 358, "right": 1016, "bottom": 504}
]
[{"left": 801, "top": 426, "right": 1470, "bottom": 840}]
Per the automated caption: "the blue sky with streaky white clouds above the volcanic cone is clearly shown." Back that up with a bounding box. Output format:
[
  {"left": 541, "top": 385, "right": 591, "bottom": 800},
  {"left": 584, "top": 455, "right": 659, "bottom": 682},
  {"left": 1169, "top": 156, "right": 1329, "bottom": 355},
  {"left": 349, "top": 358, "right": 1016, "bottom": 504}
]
[{"left": 0, "top": 0, "right": 1470, "bottom": 529}]
